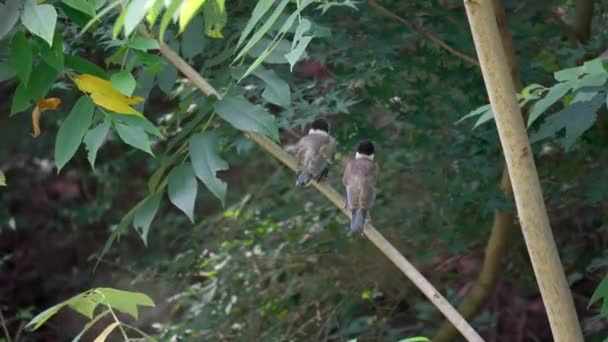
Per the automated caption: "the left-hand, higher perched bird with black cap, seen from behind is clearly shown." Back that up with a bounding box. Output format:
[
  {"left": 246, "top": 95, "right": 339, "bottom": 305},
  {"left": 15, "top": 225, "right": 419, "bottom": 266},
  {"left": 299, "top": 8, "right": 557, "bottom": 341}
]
[{"left": 296, "top": 118, "right": 336, "bottom": 187}]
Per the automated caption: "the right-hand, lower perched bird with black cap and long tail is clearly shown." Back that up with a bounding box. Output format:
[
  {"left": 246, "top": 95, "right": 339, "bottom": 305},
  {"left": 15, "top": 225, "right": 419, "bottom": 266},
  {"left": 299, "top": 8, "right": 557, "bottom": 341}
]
[{"left": 342, "top": 139, "right": 378, "bottom": 233}]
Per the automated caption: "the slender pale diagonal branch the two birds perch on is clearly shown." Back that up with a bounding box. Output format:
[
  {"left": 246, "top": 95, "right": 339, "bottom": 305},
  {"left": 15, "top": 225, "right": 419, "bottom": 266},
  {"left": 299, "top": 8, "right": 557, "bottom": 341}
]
[{"left": 140, "top": 28, "right": 483, "bottom": 341}]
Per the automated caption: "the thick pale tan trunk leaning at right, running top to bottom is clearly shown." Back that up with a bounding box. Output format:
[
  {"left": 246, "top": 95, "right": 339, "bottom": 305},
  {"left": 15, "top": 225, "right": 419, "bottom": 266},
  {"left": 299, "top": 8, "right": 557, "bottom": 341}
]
[{"left": 464, "top": 0, "right": 583, "bottom": 342}]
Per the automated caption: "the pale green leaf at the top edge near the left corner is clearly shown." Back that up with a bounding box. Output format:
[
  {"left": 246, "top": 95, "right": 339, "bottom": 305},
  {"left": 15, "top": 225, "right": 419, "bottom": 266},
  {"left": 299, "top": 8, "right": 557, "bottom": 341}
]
[{"left": 21, "top": 0, "right": 57, "bottom": 45}]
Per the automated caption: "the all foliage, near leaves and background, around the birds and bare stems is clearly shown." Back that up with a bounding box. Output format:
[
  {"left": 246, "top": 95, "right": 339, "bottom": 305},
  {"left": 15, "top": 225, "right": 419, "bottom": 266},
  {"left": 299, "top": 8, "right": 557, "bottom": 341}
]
[{"left": 0, "top": 0, "right": 608, "bottom": 341}]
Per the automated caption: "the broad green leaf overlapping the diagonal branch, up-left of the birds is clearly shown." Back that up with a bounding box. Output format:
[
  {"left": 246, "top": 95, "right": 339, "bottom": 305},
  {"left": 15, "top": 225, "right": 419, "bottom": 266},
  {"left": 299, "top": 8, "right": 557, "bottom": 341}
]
[{"left": 214, "top": 96, "right": 279, "bottom": 141}]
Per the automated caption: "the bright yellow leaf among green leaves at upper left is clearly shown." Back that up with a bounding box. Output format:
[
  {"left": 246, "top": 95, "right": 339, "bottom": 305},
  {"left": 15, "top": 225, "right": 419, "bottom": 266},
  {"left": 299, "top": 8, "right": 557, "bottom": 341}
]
[{"left": 73, "top": 74, "right": 144, "bottom": 116}]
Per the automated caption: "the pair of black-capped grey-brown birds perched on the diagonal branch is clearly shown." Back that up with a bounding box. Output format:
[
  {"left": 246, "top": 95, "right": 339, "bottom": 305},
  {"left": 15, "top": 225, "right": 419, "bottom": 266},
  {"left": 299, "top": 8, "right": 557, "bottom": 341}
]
[{"left": 296, "top": 119, "right": 378, "bottom": 232}]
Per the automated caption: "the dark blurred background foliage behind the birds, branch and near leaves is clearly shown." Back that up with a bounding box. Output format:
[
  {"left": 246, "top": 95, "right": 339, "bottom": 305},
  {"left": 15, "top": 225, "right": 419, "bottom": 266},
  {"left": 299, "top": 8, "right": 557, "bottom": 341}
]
[{"left": 0, "top": 0, "right": 608, "bottom": 341}]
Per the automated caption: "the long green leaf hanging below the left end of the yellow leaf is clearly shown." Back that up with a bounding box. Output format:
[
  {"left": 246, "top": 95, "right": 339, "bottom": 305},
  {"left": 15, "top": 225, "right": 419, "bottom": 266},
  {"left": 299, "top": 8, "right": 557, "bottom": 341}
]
[{"left": 55, "top": 96, "right": 95, "bottom": 173}]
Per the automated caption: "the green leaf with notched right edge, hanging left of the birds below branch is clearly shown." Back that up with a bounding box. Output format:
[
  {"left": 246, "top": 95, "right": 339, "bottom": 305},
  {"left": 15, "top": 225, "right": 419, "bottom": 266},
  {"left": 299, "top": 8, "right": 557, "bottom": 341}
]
[{"left": 189, "top": 133, "right": 228, "bottom": 206}]
